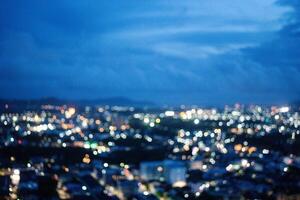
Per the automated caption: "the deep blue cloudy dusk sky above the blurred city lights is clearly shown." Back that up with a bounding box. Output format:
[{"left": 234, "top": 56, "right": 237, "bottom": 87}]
[{"left": 0, "top": 0, "right": 300, "bottom": 105}]
